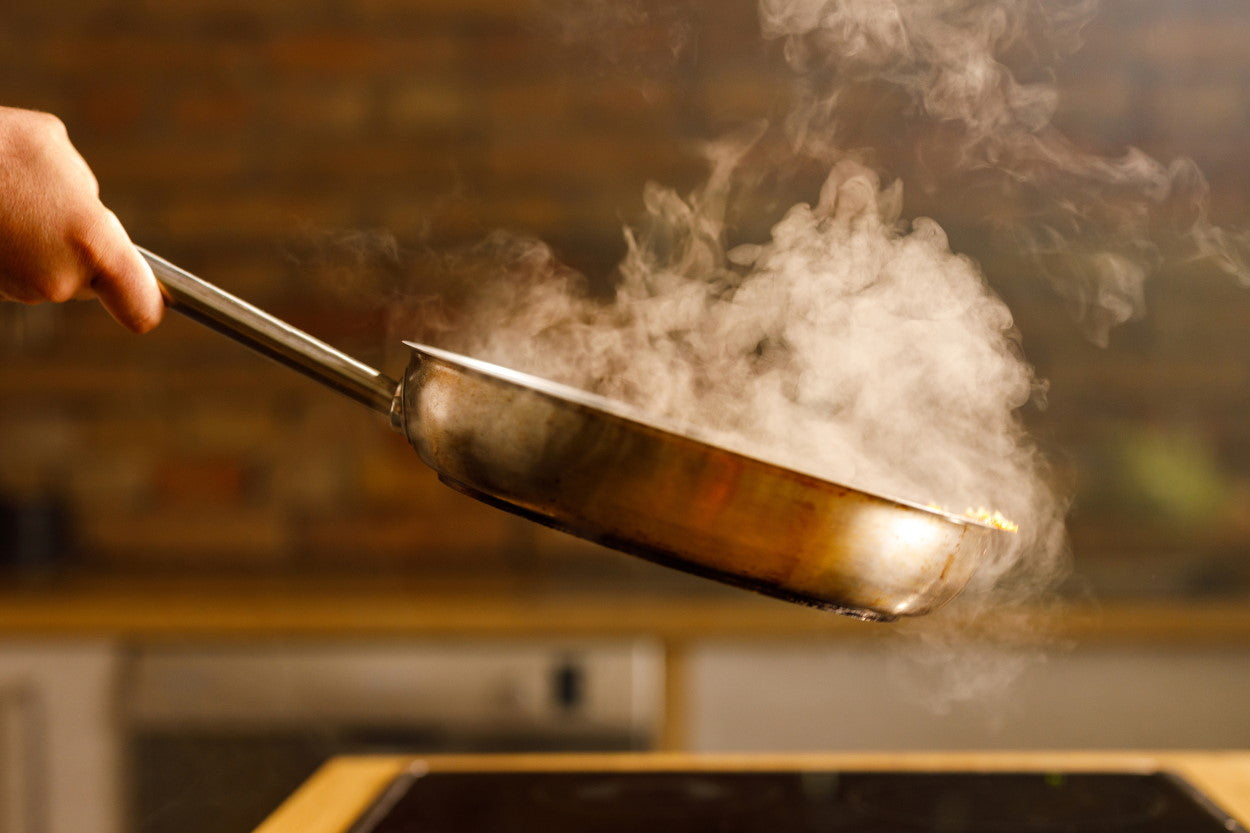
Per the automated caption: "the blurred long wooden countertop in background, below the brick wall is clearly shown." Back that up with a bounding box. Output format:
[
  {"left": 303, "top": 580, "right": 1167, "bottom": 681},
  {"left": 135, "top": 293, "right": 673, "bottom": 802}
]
[{"left": 0, "top": 574, "right": 1250, "bottom": 645}]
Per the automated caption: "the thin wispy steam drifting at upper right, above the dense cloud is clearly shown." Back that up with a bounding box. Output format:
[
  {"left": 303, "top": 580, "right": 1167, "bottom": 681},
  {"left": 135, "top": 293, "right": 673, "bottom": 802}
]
[{"left": 760, "top": 0, "right": 1250, "bottom": 344}]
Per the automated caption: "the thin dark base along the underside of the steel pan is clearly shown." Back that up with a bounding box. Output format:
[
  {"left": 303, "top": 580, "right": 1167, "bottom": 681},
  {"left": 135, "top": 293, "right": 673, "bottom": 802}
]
[{"left": 439, "top": 474, "right": 898, "bottom": 622}]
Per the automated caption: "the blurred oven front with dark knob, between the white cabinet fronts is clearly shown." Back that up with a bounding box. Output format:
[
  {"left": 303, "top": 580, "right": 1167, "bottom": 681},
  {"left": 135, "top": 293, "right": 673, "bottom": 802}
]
[{"left": 120, "top": 634, "right": 663, "bottom": 833}]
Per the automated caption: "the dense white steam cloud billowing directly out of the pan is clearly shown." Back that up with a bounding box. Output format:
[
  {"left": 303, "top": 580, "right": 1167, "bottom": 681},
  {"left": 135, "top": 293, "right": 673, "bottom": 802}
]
[{"left": 456, "top": 136, "right": 1061, "bottom": 607}]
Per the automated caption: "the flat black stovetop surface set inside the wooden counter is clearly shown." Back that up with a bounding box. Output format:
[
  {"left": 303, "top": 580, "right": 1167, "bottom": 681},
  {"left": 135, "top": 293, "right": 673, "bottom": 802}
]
[{"left": 350, "top": 772, "right": 1246, "bottom": 833}]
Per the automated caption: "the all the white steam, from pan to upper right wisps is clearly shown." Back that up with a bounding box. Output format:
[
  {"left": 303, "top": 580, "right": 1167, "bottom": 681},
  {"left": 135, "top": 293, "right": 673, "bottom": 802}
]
[{"left": 390, "top": 0, "right": 1250, "bottom": 699}]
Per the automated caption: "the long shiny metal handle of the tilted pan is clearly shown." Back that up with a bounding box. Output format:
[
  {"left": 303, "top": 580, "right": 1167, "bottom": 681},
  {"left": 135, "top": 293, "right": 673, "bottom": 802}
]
[{"left": 135, "top": 246, "right": 399, "bottom": 423}]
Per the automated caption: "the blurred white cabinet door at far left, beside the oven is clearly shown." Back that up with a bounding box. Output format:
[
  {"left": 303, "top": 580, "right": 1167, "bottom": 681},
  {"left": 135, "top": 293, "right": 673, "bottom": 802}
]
[{"left": 0, "top": 640, "right": 123, "bottom": 833}]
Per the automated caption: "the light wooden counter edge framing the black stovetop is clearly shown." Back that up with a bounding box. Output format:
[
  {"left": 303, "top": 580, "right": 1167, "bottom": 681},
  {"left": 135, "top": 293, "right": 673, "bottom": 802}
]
[{"left": 255, "top": 750, "right": 1250, "bottom": 833}]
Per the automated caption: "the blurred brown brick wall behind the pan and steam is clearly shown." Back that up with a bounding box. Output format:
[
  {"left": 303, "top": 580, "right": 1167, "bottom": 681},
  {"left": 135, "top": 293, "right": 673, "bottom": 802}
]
[{"left": 0, "top": 0, "right": 1250, "bottom": 582}]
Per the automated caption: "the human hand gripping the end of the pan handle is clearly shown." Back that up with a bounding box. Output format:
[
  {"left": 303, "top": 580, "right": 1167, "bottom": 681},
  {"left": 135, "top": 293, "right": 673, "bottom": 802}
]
[{"left": 0, "top": 108, "right": 165, "bottom": 333}]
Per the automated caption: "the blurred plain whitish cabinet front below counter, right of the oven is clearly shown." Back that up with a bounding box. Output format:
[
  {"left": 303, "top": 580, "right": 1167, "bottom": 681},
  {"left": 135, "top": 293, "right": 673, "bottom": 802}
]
[{"left": 686, "top": 642, "right": 1250, "bottom": 752}]
